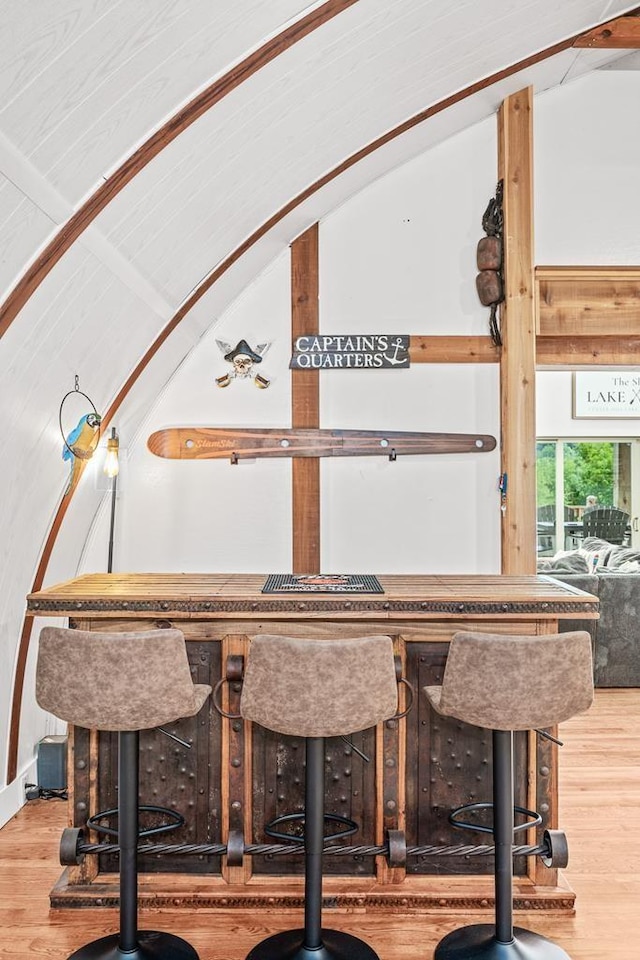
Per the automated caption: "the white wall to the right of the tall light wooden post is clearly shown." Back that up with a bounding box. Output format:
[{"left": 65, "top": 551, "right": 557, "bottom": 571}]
[{"left": 534, "top": 70, "right": 640, "bottom": 438}]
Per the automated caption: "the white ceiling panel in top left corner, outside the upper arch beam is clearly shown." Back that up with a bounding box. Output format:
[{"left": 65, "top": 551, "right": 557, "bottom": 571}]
[{"left": 0, "top": 0, "right": 315, "bottom": 203}]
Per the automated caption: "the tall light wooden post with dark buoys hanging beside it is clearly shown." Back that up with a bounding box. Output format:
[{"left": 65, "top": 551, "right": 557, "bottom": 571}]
[{"left": 498, "top": 87, "right": 536, "bottom": 574}]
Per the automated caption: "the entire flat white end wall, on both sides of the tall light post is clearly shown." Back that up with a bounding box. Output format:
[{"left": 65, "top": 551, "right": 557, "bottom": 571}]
[{"left": 83, "top": 72, "right": 640, "bottom": 572}]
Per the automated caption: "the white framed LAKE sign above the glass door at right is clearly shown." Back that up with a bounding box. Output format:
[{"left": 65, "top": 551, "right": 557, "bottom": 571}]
[{"left": 573, "top": 369, "right": 640, "bottom": 420}]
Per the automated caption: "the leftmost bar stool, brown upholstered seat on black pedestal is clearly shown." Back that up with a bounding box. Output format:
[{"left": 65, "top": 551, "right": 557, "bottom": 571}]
[{"left": 36, "top": 627, "right": 211, "bottom": 960}]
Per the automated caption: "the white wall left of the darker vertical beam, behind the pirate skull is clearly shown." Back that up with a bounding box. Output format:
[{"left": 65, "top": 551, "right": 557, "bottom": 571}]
[{"left": 82, "top": 255, "right": 298, "bottom": 572}]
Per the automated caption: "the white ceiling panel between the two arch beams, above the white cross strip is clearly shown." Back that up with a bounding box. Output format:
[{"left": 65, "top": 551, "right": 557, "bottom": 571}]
[{"left": 91, "top": 0, "right": 640, "bottom": 302}]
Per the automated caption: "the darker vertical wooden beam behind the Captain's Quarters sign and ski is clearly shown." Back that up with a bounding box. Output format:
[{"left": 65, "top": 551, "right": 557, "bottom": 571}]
[{"left": 291, "top": 223, "right": 320, "bottom": 573}]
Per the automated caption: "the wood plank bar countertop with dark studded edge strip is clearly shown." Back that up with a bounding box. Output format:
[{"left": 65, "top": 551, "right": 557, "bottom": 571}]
[{"left": 27, "top": 573, "right": 598, "bottom": 620}]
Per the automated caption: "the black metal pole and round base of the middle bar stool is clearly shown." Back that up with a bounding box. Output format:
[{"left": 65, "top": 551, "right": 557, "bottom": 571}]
[{"left": 247, "top": 737, "right": 379, "bottom": 960}]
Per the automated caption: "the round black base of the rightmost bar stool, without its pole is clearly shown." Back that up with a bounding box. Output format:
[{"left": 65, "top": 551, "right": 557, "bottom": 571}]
[{"left": 434, "top": 923, "right": 569, "bottom": 960}]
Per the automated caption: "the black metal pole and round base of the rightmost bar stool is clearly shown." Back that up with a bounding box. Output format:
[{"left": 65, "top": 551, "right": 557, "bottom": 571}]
[{"left": 434, "top": 730, "right": 569, "bottom": 960}]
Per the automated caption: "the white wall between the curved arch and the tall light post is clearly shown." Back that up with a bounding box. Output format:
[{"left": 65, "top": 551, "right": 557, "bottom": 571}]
[{"left": 83, "top": 122, "right": 500, "bottom": 573}]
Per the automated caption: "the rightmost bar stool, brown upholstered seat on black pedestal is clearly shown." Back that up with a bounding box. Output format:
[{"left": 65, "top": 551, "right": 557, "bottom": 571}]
[{"left": 424, "top": 630, "right": 593, "bottom": 960}]
